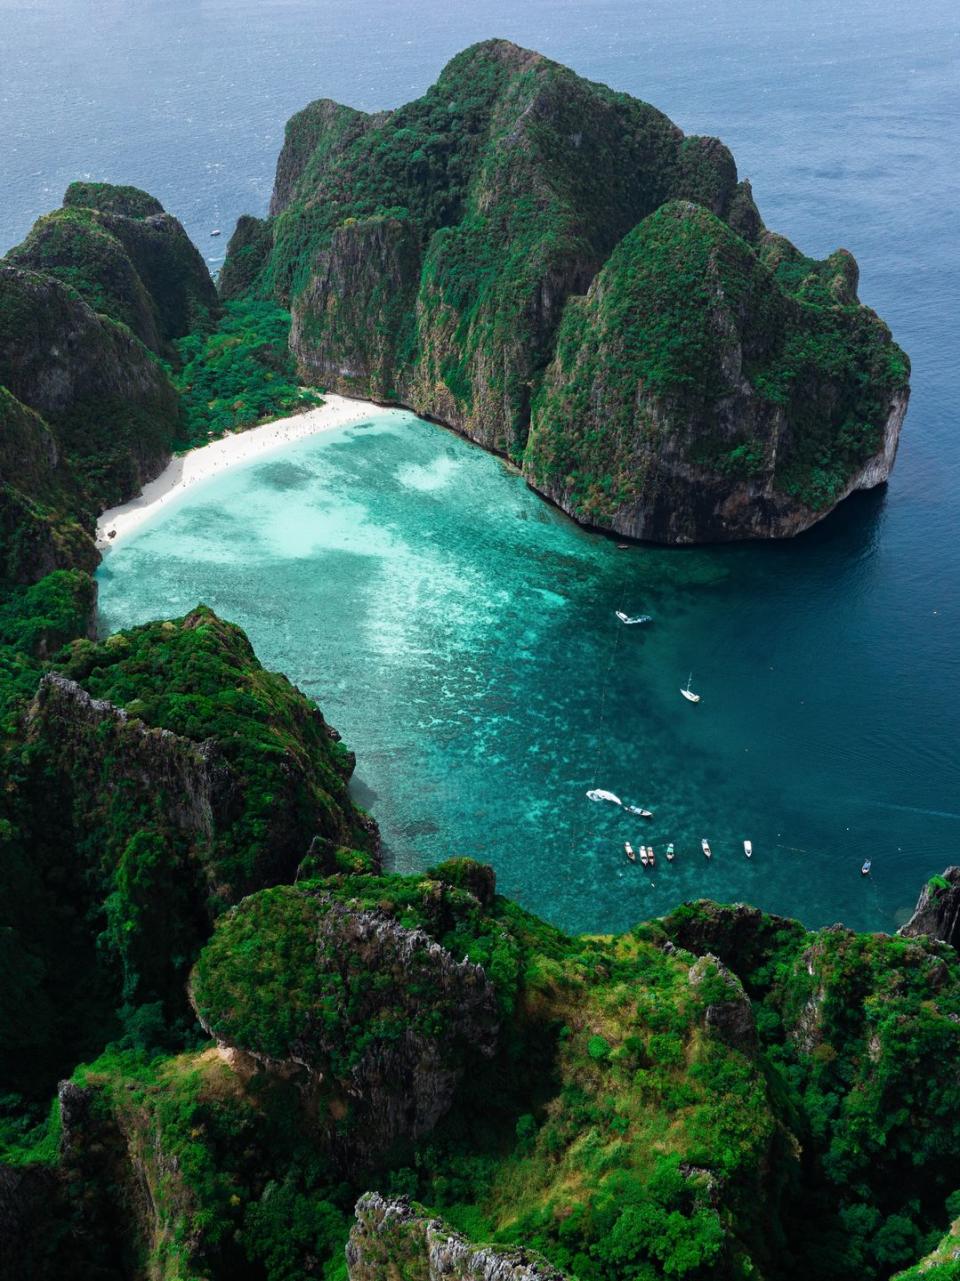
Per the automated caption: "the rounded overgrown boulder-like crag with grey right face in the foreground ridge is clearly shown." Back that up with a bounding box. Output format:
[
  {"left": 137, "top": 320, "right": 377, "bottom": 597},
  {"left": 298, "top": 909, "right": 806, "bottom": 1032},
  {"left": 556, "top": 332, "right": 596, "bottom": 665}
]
[{"left": 191, "top": 886, "right": 497, "bottom": 1161}]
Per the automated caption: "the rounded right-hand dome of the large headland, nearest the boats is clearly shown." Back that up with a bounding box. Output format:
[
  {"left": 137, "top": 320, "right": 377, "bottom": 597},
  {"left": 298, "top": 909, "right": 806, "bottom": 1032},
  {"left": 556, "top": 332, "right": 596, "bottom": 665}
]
[{"left": 523, "top": 202, "right": 907, "bottom": 543}]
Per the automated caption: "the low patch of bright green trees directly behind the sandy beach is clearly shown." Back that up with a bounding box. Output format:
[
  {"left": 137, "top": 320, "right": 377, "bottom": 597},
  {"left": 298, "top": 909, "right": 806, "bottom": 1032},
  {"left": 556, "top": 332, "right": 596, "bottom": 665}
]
[{"left": 173, "top": 301, "right": 323, "bottom": 448}]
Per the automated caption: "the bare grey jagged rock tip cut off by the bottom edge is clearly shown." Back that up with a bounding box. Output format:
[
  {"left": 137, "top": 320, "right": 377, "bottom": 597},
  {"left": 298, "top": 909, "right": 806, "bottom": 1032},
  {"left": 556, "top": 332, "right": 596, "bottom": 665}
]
[{"left": 346, "top": 1193, "right": 564, "bottom": 1281}]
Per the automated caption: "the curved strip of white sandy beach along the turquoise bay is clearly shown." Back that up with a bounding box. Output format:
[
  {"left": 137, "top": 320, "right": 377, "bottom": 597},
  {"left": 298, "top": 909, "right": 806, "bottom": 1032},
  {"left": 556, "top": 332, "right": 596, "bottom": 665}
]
[{"left": 96, "top": 393, "right": 392, "bottom": 551}]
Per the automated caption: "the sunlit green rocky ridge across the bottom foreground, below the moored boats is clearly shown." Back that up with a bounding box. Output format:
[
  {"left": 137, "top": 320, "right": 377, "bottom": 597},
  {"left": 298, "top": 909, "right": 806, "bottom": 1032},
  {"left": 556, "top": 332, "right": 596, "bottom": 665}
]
[{"left": 0, "top": 852, "right": 960, "bottom": 1281}]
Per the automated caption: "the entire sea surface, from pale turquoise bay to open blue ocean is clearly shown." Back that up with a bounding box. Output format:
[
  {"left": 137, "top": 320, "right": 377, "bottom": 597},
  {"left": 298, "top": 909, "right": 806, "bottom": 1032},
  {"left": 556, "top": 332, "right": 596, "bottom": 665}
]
[{"left": 0, "top": 0, "right": 960, "bottom": 930}]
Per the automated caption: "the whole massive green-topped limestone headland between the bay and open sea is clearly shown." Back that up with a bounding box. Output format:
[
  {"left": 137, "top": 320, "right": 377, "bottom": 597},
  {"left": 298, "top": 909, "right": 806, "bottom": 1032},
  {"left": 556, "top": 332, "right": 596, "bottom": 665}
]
[{"left": 220, "top": 40, "right": 909, "bottom": 543}]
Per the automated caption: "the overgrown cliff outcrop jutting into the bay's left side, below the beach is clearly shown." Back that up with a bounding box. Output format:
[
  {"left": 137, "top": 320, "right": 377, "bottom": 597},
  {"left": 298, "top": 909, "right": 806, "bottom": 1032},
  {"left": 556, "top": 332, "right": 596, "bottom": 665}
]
[{"left": 17, "top": 610, "right": 377, "bottom": 1045}]
